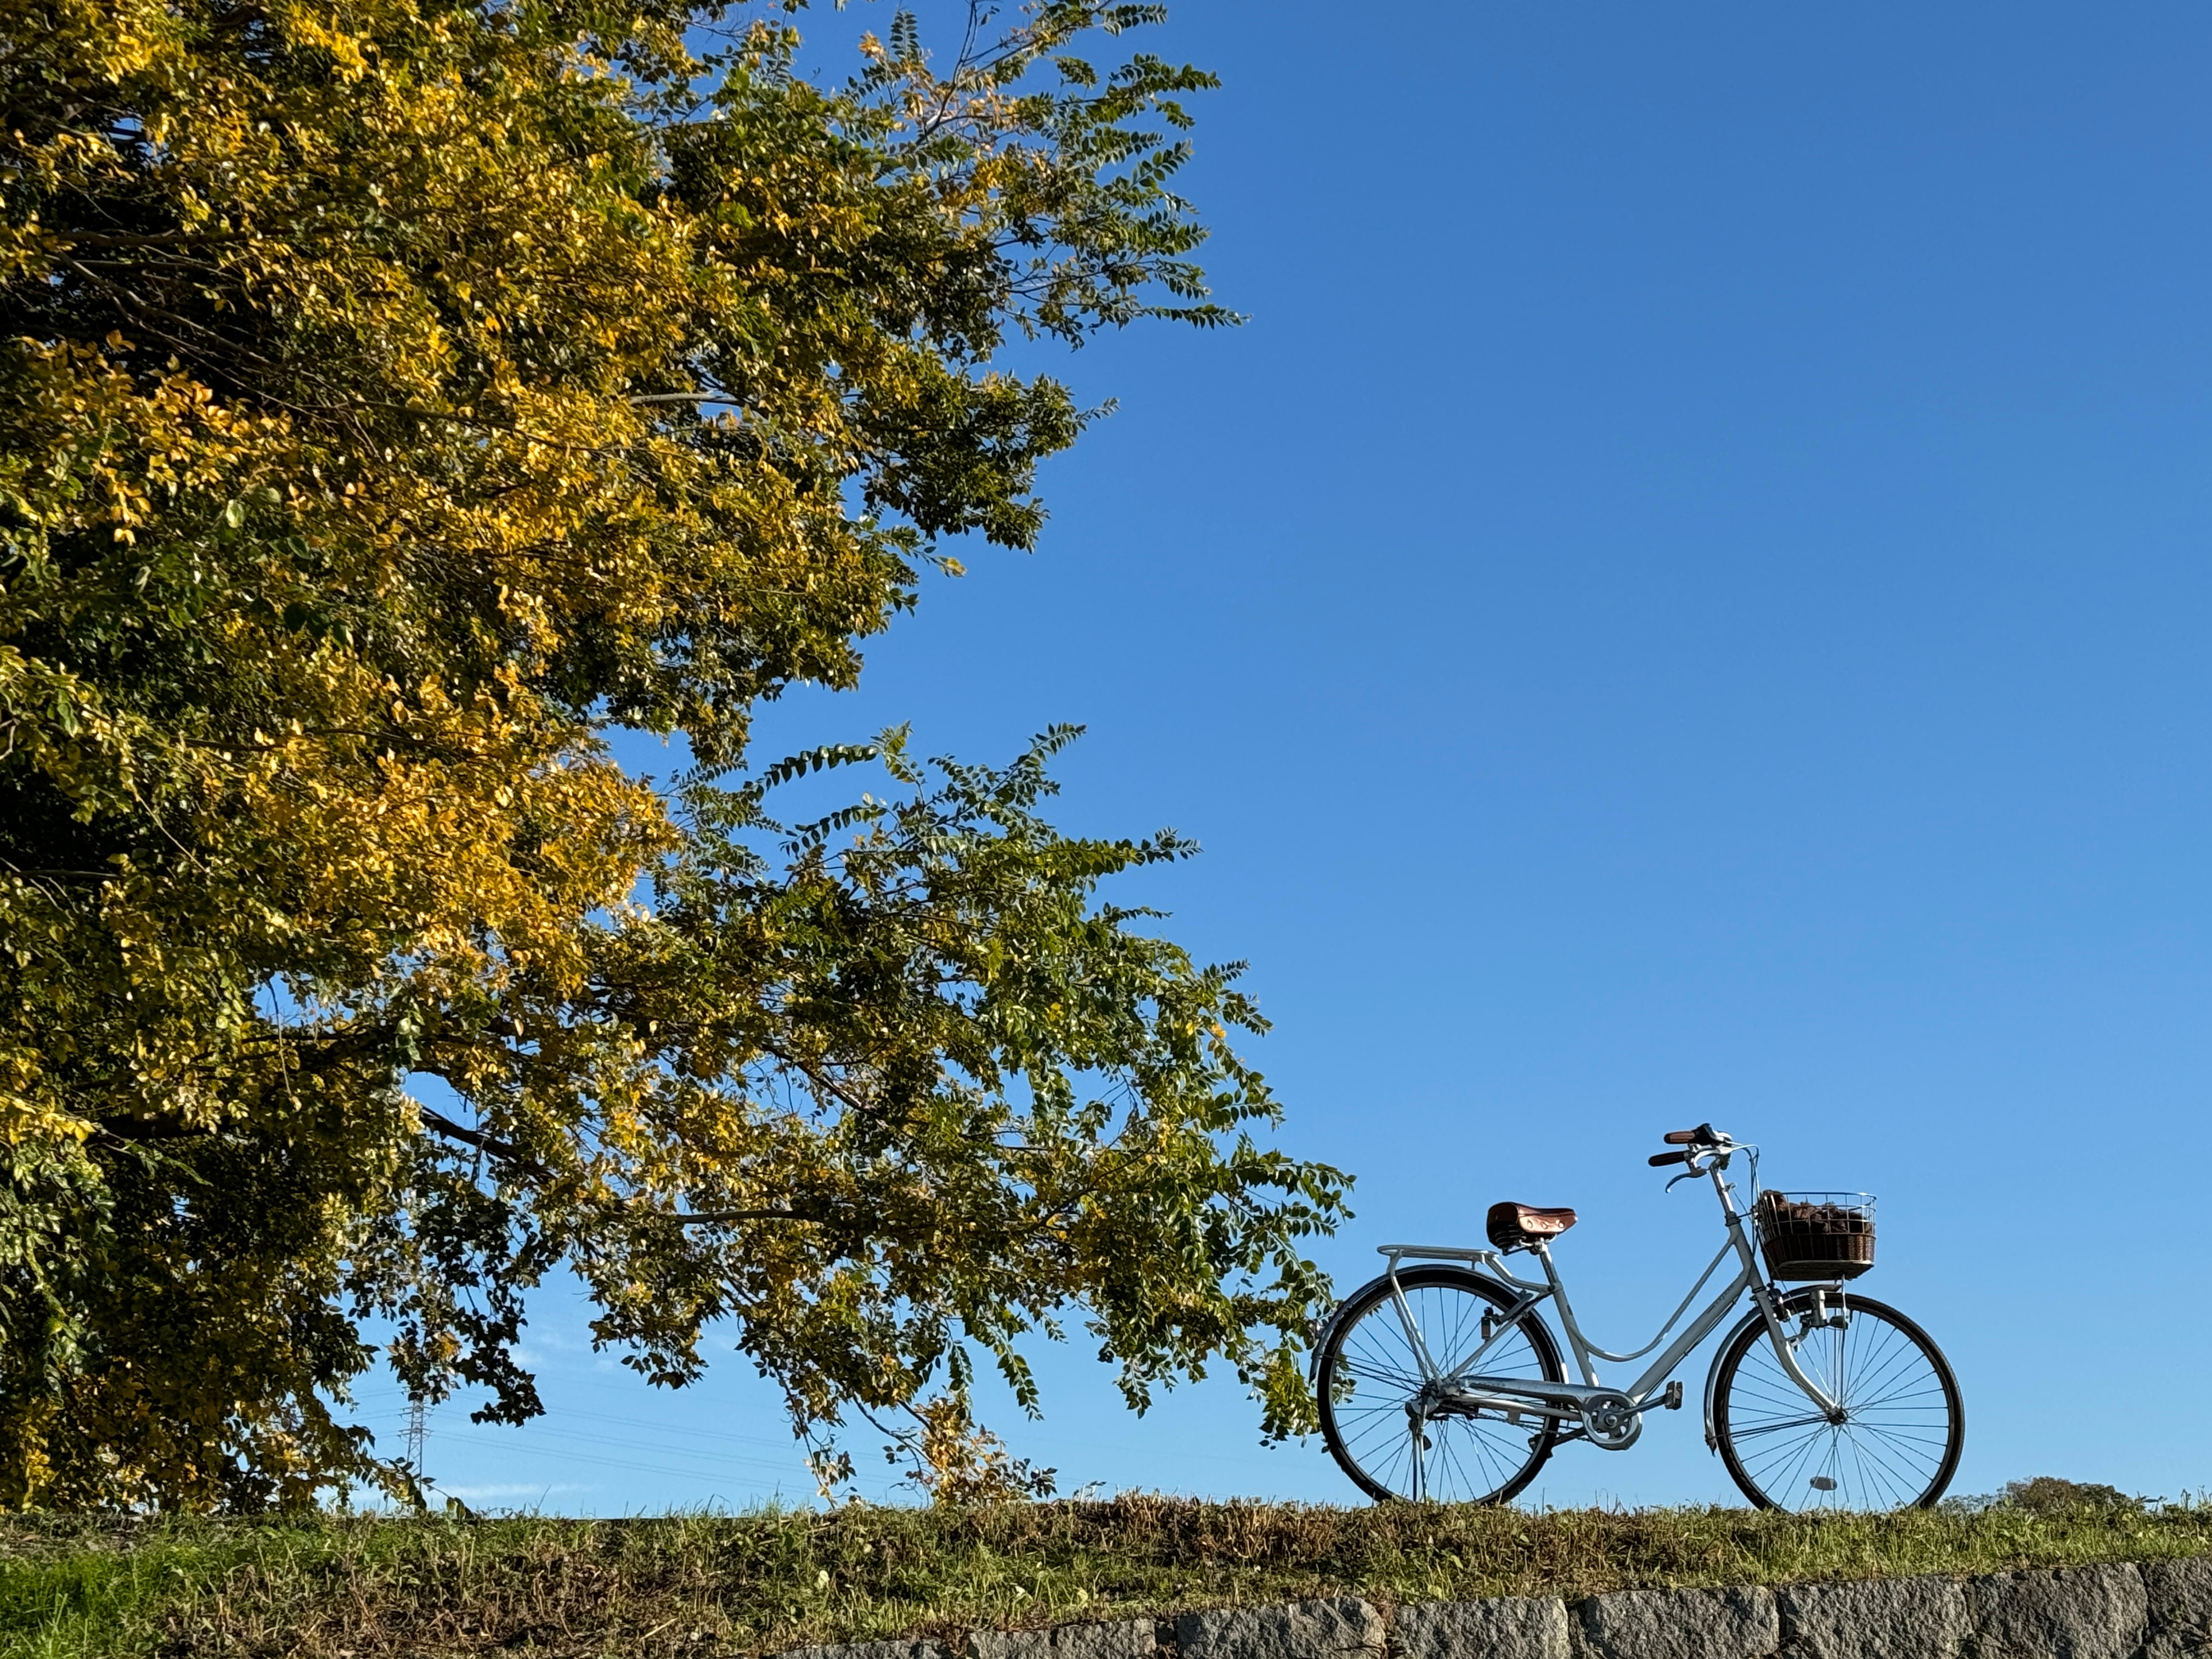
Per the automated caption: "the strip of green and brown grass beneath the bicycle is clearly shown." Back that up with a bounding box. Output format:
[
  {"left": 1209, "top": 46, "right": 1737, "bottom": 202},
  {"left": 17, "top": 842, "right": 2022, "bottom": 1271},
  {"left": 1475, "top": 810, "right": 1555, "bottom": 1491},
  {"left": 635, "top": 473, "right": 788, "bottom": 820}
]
[{"left": 0, "top": 1496, "right": 2212, "bottom": 1659}]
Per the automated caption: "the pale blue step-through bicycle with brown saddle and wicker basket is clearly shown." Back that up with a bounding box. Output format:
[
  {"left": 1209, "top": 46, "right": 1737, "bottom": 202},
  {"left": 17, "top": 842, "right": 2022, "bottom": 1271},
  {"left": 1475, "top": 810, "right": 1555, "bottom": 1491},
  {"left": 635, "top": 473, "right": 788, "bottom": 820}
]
[{"left": 1314, "top": 1124, "right": 1966, "bottom": 1509}]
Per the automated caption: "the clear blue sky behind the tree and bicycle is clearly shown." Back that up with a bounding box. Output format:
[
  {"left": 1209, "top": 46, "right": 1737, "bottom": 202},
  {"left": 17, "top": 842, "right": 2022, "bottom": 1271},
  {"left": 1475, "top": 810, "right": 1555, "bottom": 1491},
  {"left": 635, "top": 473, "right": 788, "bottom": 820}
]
[{"left": 385, "top": 0, "right": 2212, "bottom": 1513}]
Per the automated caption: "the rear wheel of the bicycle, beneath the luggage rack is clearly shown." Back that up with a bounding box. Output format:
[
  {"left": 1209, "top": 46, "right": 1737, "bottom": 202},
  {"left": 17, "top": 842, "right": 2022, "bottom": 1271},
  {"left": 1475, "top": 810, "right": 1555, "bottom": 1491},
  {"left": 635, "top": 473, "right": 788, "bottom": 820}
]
[{"left": 1314, "top": 1265, "right": 1566, "bottom": 1504}]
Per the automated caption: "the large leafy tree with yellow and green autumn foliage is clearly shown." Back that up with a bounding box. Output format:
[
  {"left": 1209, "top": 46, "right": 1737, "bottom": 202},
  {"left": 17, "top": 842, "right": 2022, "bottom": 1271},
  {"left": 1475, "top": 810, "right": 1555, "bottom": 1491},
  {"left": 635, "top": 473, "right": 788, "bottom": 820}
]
[{"left": 0, "top": 0, "right": 1345, "bottom": 1509}]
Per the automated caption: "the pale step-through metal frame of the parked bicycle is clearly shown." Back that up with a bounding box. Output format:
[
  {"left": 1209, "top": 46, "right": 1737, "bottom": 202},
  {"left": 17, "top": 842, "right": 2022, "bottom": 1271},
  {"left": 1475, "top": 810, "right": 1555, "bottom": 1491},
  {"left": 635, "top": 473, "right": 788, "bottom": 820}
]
[{"left": 1380, "top": 1146, "right": 1849, "bottom": 1496}]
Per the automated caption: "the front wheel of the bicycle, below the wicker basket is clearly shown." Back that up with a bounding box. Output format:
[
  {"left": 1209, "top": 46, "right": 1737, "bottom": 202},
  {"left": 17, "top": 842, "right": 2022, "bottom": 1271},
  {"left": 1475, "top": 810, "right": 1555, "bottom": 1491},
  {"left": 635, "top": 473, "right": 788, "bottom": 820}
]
[{"left": 1712, "top": 1290, "right": 1966, "bottom": 1511}]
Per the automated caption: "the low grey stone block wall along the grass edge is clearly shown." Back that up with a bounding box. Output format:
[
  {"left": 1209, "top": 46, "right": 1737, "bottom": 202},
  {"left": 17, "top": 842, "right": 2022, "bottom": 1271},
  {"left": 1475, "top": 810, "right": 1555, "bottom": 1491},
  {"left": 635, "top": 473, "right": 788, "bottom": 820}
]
[{"left": 787, "top": 1558, "right": 2212, "bottom": 1659}]
